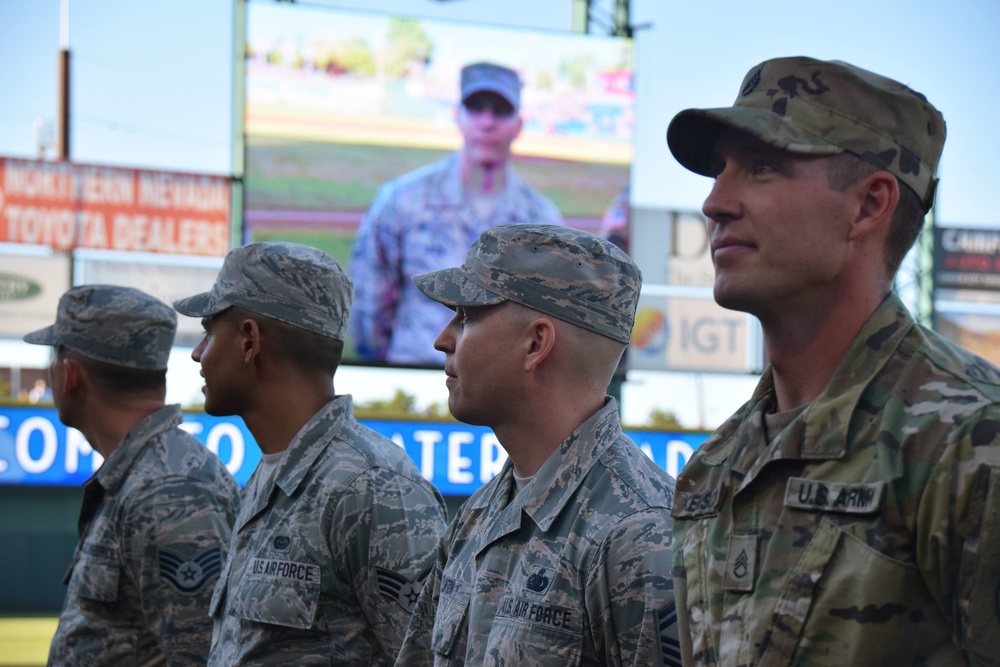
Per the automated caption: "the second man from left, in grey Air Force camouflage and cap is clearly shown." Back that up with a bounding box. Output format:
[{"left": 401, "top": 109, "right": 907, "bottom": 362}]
[{"left": 174, "top": 243, "right": 446, "bottom": 667}]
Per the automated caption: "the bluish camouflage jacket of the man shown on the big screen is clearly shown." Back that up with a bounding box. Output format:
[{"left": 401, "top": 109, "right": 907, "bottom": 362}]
[{"left": 350, "top": 153, "right": 562, "bottom": 366}]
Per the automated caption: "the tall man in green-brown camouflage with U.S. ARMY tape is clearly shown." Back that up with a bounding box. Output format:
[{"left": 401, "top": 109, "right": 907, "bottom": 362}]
[{"left": 667, "top": 57, "right": 1000, "bottom": 666}]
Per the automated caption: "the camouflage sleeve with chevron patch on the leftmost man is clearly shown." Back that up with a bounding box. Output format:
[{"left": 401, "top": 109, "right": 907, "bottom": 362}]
[{"left": 121, "top": 477, "right": 236, "bottom": 665}]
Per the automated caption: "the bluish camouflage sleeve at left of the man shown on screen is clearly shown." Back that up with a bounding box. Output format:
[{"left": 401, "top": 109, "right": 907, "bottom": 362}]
[{"left": 348, "top": 187, "right": 402, "bottom": 361}]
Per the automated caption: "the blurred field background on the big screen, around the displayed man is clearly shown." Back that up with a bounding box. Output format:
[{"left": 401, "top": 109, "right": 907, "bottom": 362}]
[{"left": 243, "top": 2, "right": 635, "bottom": 366}]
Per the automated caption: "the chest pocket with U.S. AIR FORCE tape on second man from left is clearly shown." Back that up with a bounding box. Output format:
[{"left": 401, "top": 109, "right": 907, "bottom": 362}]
[{"left": 230, "top": 559, "right": 321, "bottom": 630}]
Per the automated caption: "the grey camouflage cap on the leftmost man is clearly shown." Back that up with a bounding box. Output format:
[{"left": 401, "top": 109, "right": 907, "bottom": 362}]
[{"left": 23, "top": 285, "right": 177, "bottom": 370}]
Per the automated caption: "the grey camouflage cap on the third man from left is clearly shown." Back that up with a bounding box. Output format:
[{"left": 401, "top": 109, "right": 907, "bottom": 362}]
[{"left": 413, "top": 225, "right": 642, "bottom": 343}]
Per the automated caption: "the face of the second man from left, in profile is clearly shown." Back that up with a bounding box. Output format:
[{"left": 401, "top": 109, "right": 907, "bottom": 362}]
[{"left": 191, "top": 309, "right": 247, "bottom": 416}]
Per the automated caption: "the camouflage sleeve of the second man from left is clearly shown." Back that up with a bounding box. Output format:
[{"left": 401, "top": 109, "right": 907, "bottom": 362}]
[{"left": 330, "top": 468, "right": 445, "bottom": 656}]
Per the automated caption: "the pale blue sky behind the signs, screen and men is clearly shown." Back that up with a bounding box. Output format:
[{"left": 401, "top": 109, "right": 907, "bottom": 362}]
[{"left": 0, "top": 0, "right": 1000, "bottom": 428}]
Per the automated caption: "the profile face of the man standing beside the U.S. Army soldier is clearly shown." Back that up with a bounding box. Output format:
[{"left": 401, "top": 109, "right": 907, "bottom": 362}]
[{"left": 434, "top": 302, "right": 524, "bottom": 429}]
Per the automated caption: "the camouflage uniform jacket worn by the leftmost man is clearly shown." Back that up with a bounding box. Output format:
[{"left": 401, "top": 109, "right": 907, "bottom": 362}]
[{"left": 49, "top": 405, "right": 239, "bottom": 667}]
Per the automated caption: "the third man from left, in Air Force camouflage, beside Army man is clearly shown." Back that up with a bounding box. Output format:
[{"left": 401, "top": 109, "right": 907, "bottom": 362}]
[{"left": 396, "top": 225, "right": 680, "bottom": 667}]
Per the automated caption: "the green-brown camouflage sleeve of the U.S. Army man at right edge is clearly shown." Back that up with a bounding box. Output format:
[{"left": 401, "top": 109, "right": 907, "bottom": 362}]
[{"left": 916, "top": 416, "right": 1000, "bottom": 665}]
